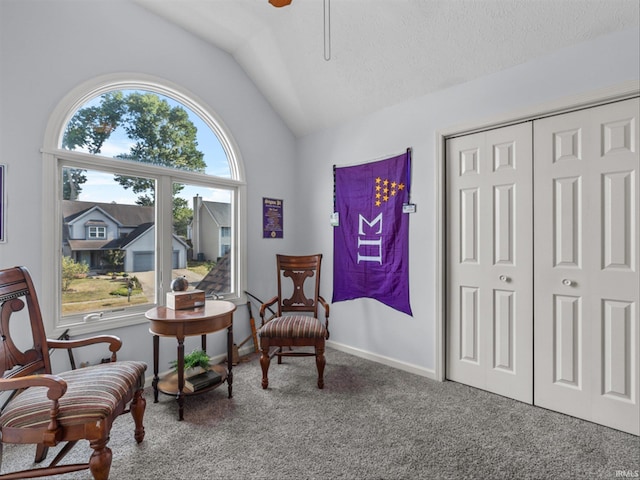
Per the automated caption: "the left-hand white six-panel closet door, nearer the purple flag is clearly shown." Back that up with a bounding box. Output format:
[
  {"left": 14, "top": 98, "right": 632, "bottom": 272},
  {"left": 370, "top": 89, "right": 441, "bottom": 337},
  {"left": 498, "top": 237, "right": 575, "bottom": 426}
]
[{"left": 446, "top": 123, "right": 533, "bottom": 403}]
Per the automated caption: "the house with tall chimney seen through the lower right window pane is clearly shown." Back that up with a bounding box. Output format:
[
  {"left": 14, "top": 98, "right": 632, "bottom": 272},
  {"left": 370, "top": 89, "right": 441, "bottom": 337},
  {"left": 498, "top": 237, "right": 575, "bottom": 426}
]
[{"left": 187, "top": 196, "right": 231, "bottom": 261}]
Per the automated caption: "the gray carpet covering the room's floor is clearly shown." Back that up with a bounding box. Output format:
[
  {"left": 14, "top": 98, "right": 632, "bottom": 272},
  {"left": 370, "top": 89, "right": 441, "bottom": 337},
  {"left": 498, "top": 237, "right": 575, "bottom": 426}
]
[{"left": 2, "top": 349, "right": 640, "bottom": 480}]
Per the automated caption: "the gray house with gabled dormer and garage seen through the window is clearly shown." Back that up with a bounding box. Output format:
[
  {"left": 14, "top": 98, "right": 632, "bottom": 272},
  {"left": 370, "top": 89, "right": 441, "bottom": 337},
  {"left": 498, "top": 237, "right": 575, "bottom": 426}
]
[{"left": 62, "top": 200, "right": 189, "bottom": 272}]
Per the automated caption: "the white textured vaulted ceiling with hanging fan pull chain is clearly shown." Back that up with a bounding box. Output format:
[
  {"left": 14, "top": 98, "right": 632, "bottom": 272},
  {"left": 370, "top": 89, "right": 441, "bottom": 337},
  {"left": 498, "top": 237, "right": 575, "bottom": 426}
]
[{"left": 135, "top": 0, "right": 640, "bottom": 136}]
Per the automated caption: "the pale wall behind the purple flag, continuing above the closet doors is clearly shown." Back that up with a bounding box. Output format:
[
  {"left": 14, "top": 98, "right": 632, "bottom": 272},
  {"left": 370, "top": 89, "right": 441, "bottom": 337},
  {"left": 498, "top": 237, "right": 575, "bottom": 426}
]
[{"left": 297, "top": 29, "right": 640, "bottom": 376}]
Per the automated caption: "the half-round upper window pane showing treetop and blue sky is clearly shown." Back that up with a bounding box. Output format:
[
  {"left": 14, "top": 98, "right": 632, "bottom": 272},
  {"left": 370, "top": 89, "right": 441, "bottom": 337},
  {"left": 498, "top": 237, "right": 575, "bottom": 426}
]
[{"left": 62, "top": 90, "right": 231, "bottom": 178}]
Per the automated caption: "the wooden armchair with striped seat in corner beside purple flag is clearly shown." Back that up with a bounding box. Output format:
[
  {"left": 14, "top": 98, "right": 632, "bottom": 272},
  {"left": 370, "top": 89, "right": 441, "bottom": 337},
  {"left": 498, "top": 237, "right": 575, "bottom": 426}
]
[{"left": 259, "top": 254, "right": 329, "bottom": 388}]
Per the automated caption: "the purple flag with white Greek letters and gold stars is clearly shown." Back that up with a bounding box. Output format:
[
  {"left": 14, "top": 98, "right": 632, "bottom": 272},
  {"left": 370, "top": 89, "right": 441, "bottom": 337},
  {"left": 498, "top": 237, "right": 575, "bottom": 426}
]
[{"left": 333, "top": 151, "right": 413, "bottom": 315}]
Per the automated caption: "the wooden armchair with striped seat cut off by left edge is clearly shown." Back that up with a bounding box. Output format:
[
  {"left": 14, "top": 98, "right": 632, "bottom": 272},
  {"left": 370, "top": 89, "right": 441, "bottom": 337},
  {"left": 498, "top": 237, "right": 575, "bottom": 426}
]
[{"left": 0, "top": 267, "right": 147, "bottom": 480}]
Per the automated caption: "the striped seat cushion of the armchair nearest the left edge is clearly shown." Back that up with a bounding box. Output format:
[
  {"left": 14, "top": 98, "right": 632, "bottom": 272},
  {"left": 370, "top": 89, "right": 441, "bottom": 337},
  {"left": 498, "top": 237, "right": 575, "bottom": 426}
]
[{"left": 0, "top": 361, "right": 147, "bottom": 428}]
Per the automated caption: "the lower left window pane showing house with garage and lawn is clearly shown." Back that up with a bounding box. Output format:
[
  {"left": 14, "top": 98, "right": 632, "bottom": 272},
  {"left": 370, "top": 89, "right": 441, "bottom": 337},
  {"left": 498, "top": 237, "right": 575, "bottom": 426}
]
[{"left": 61, "top": 167, "right": 156, "bottom": 321}]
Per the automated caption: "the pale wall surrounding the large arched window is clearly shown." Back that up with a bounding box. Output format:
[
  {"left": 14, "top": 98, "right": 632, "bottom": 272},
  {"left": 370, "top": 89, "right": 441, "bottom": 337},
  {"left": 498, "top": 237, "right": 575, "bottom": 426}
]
[{"left": 0, "top": 0, "right": 295, "bottom": 373}]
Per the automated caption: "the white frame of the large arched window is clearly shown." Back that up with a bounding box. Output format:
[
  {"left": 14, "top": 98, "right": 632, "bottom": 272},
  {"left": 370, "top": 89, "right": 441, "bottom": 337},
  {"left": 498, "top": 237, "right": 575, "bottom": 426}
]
[{"left": 39, "top": 73, "right": 247, "bottom": 336}]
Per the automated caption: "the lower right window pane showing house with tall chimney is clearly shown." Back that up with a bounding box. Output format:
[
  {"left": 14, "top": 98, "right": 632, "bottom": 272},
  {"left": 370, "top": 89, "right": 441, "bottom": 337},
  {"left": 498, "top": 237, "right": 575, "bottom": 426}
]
[{"left": 172, "top": 183, "right": 235, "bottom": 297}]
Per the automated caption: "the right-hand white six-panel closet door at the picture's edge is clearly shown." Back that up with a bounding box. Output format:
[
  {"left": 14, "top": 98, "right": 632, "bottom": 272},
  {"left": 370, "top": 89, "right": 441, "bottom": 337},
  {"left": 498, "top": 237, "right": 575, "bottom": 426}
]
[{"left": 534, "top": 99, "right": 640, "bottom": 435}]
